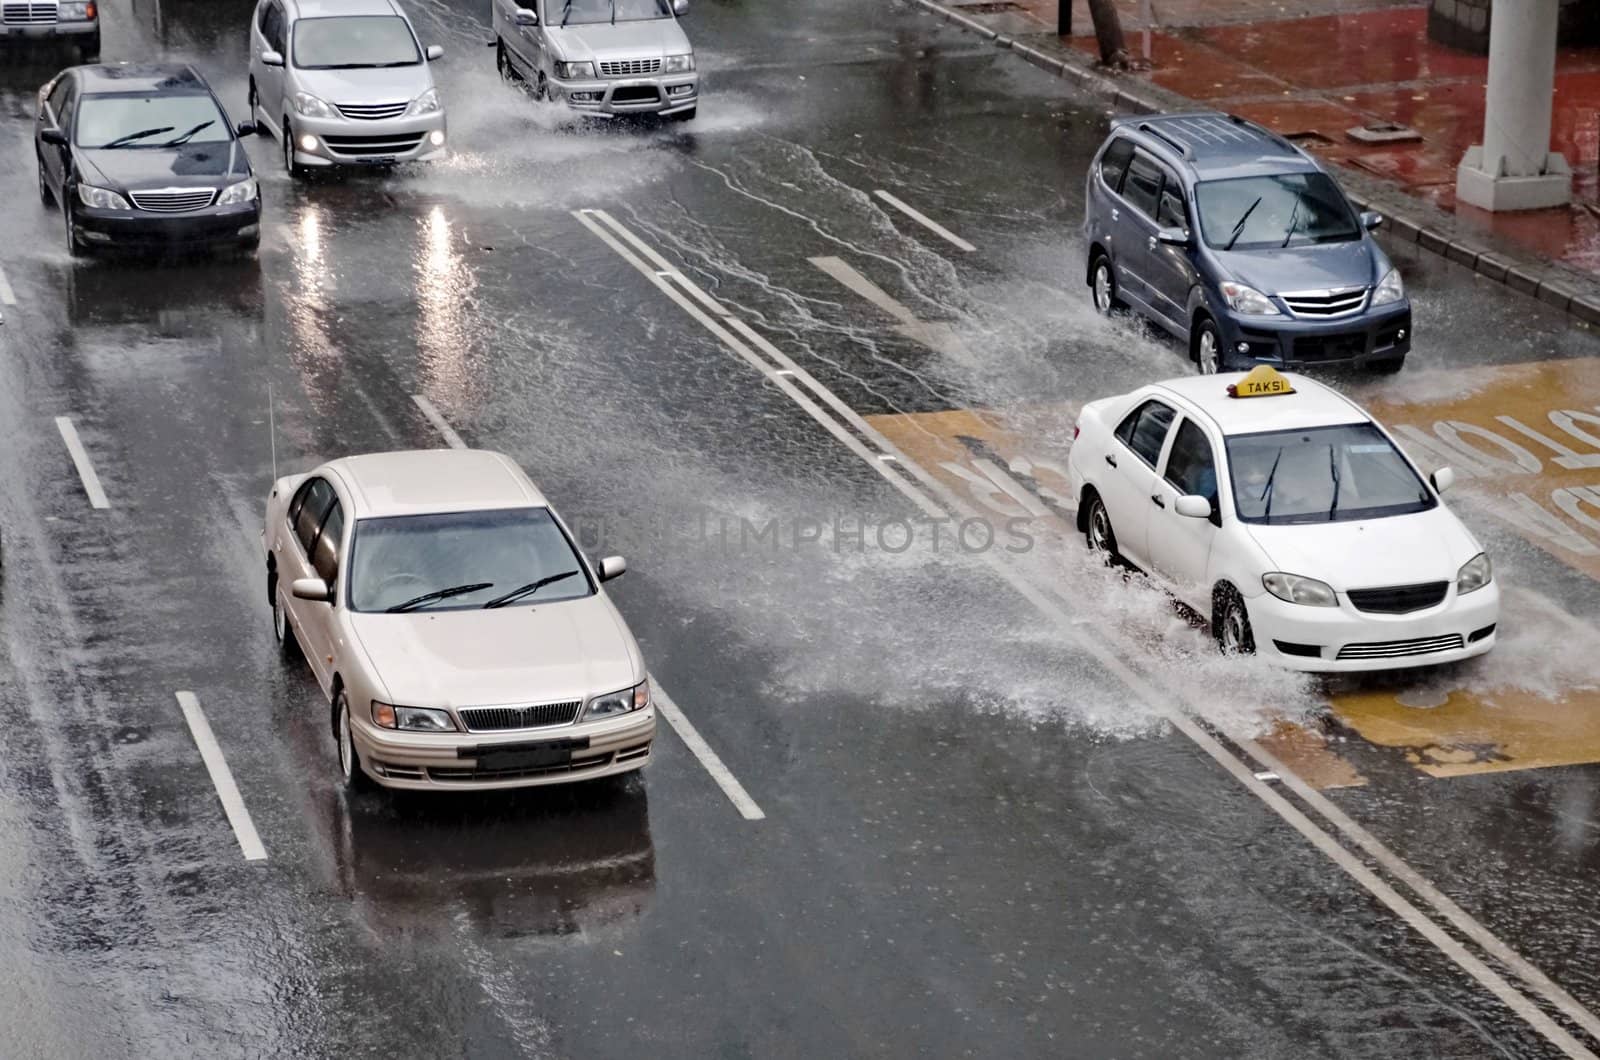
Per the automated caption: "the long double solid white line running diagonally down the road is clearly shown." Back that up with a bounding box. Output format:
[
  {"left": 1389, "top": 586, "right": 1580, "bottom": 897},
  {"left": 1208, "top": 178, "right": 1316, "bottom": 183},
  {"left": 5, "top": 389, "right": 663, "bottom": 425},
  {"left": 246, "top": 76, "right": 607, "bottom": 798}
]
[{"left": 573, "top": 210, "right": 1600, "bottom": 1060}]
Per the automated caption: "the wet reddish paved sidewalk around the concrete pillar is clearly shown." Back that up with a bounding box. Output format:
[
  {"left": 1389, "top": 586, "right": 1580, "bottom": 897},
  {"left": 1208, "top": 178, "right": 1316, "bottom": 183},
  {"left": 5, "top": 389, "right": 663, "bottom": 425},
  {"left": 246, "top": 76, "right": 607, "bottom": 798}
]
[{"left": 938, "top": 0, "right": 1600, "bottom": 312}]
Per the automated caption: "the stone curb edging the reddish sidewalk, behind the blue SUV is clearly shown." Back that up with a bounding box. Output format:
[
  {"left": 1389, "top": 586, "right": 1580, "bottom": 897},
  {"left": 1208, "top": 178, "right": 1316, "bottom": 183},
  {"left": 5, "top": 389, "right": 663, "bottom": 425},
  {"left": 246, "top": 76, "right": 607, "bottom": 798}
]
[{"left": 910, "top": 0, "right": 1600, "bottom": 325}]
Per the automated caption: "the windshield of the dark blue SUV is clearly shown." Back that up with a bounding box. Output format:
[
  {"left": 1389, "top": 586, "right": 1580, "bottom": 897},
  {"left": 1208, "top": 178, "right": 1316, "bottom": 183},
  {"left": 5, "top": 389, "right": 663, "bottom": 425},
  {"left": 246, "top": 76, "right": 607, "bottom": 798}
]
[{"left": 1195, "top": 173, "right": 1362, "bottom": 250}]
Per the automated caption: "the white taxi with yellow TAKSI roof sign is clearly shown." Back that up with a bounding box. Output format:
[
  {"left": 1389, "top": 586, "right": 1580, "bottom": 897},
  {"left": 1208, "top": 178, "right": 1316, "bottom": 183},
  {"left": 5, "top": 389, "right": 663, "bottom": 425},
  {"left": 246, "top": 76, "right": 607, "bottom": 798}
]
[{"left": 1069, "top": 365, "right": 1499, "bottom": 673}]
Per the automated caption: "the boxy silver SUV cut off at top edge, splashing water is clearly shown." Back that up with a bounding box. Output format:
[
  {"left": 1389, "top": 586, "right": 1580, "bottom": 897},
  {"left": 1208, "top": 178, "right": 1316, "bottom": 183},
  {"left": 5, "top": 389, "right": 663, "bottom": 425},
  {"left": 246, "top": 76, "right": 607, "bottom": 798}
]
[{"left": 494, "top": 0, "right": 699, "bottom": 122}]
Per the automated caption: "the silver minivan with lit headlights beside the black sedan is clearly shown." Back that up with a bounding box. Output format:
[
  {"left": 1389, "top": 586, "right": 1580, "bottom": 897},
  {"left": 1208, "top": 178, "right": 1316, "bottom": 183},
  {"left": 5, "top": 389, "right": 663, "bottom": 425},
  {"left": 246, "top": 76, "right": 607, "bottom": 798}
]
[{"left": 250, "top": 0, "right": 445, "bottom": 176}]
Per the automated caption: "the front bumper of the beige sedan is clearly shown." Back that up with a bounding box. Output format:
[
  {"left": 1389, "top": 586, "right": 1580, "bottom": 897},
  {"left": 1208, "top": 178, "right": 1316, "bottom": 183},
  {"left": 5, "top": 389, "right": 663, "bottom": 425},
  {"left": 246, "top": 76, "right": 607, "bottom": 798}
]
[{"left": 350, "top": 706, "right": 656, "bottom": 791}]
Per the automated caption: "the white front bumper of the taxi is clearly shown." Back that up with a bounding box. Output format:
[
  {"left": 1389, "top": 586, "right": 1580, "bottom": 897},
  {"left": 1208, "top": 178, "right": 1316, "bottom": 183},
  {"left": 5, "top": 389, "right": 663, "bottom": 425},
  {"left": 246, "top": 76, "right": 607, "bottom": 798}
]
[{"left": 1245, "top": 581, "right": 1499, "bottom": 674}]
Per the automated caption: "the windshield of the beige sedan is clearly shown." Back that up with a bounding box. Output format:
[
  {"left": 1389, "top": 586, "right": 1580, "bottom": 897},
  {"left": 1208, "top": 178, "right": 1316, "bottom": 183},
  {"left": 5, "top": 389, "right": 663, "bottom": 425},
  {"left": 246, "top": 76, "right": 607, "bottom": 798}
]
[{"left": 350, "top": 508, "right": 594, "bottom": 612}]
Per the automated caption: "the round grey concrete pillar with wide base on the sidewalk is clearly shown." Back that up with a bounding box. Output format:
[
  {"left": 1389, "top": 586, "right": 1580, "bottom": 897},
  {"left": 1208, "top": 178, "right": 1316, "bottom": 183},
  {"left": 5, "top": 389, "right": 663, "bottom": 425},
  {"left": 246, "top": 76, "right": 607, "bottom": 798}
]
[{"left": 1456, "top": 0, "right": 1573, "bottom": 210}]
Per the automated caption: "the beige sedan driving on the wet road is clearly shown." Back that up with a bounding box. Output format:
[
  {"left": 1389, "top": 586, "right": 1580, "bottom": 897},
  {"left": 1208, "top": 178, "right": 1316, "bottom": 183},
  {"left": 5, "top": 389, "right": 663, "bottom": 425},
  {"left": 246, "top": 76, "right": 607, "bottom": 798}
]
[{"left": 262, "top": 450, "right": 656, "bottom": 791}]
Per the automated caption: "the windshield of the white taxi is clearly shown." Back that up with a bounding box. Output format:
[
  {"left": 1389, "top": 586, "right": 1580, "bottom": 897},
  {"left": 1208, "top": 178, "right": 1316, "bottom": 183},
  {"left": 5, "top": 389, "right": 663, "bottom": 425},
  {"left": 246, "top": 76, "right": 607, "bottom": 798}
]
[{"left": 1227, "top": 422, "right": 1438, "bottom": 524}]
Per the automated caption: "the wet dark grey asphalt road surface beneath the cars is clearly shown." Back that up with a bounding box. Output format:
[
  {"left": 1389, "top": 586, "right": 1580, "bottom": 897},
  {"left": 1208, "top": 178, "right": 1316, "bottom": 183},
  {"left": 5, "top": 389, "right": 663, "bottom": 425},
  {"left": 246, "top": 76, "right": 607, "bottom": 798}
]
[{"left": 0, "top": 0, "right": 1600, "bottom": 1057}]
